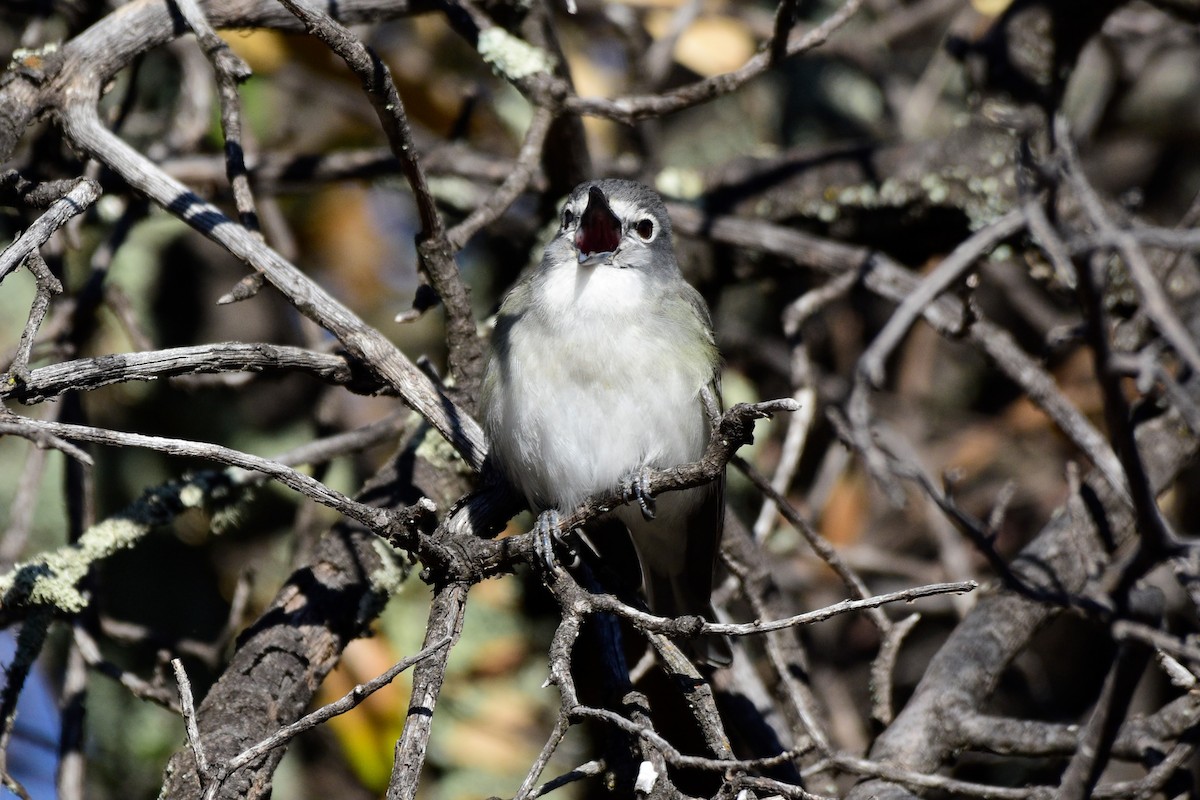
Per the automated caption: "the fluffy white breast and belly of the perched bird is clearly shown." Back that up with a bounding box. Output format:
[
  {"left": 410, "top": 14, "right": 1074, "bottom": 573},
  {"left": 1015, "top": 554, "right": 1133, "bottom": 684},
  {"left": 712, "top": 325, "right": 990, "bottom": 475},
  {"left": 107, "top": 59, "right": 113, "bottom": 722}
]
[{"left": 493, "top": 266, "right": 712, "bottom": 509}]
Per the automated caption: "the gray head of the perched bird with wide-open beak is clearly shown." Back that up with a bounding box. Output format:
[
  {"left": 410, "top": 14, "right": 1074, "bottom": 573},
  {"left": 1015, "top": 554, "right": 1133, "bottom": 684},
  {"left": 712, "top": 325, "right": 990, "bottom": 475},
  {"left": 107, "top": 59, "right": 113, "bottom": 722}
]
[{"left": 546, "top": 179, "right": 679, "bottom": 278}]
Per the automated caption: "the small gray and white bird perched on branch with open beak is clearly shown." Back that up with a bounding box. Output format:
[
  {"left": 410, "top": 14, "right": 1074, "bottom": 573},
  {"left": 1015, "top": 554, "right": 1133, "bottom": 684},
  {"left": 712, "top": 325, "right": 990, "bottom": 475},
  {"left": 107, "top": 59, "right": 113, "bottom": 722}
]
[{"left": 480, "top": 179, "right": 732, "bottom": 667}]
